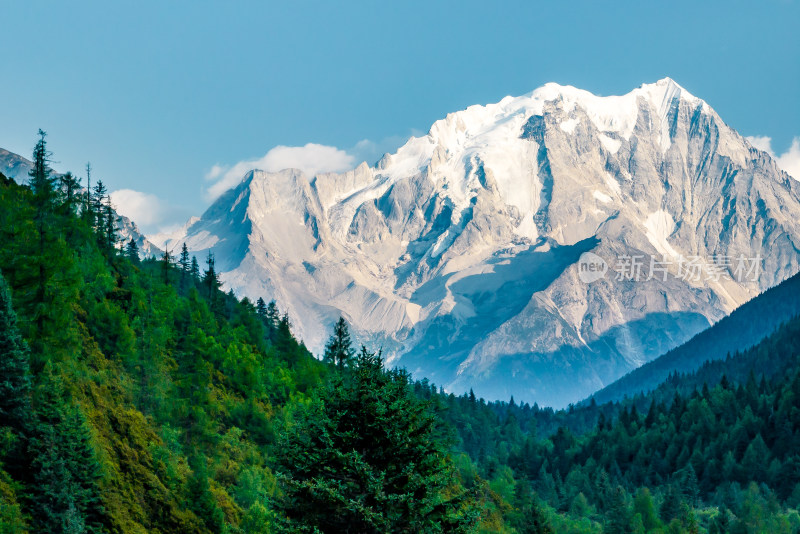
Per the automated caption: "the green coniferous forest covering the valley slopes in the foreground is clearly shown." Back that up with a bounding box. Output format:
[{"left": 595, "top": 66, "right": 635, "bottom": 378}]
[{"left": 0, "top": 132, "right": 800, "bottom": 534}]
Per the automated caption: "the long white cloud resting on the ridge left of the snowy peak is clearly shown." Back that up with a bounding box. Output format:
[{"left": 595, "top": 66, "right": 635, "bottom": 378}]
[{"left": 206, "top": 143, "right": 357, "bottom": 200}]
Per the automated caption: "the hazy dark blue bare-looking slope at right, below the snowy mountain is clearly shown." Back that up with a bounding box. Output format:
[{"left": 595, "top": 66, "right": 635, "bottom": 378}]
[{"left": 592, "top": 274, "right": 800, "bottom": 403}]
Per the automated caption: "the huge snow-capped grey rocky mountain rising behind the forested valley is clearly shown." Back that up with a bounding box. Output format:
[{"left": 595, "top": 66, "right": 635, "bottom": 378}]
[{"left": 159, "top": 78, "right": 800, "bottom": 406}]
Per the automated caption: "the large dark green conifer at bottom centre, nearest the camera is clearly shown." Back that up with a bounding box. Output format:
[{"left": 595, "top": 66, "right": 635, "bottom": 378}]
[{"left": 278, "top": 348, "right": 475, "bottom": 532}]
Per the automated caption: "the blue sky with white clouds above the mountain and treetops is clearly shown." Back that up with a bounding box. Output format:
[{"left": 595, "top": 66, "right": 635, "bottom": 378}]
[{"left": 0, "top": 0, "right": 800, "bottom": 231}]
